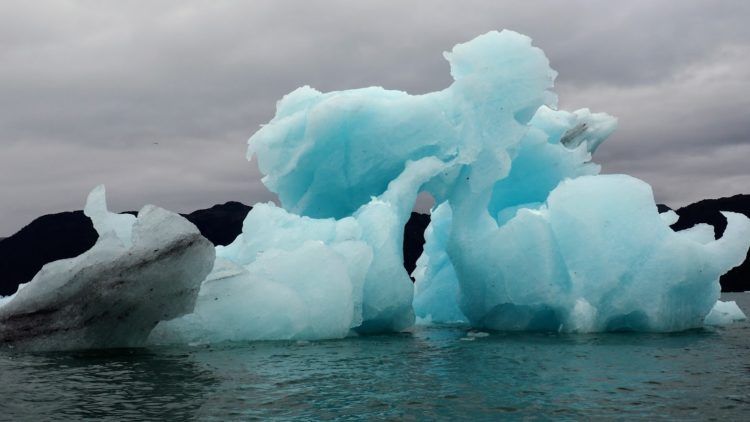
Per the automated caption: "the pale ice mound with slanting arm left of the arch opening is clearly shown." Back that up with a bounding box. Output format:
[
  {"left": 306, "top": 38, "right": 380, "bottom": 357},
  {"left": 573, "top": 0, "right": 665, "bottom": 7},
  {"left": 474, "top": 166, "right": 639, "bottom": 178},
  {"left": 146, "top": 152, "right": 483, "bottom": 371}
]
[{"left": 151, "top": 157, "right": 445, "bottom": 343}]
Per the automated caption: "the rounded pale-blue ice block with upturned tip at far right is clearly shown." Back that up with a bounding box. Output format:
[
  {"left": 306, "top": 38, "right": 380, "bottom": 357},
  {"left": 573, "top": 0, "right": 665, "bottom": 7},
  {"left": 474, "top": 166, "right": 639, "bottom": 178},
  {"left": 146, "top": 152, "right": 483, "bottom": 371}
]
[{"left": 446, "top": 175, "right": 750, "bottom": 332}]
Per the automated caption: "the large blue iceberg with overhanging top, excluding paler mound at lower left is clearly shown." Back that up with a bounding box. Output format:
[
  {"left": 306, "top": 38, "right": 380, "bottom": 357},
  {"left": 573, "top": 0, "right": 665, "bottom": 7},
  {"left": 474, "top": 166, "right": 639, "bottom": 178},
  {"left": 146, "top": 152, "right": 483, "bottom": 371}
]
[{"left": 241, "top": 31, "right": 750, "bottom": 332}]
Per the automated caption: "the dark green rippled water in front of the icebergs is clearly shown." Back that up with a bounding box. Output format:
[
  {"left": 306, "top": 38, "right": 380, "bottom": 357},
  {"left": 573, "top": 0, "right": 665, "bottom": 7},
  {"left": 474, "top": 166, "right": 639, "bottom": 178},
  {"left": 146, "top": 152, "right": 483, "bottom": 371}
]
[{"left": 0, "top": 293, "right": 750, "bottom": 421}]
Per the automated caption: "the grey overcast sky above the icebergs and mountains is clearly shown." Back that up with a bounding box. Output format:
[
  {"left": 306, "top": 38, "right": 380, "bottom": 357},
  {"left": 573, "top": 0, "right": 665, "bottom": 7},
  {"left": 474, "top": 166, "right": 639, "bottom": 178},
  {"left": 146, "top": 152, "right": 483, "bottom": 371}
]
[{"left": 0, "top": 0, "right": 750, "bottom": 236}]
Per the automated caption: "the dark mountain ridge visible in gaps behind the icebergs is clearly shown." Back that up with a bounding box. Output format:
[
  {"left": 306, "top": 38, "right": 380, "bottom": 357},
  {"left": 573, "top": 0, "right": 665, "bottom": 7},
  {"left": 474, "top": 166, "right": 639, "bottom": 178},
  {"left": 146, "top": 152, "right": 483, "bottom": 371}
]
[{"left": 0, "top": 194, "right": 750, "bottom": 296}]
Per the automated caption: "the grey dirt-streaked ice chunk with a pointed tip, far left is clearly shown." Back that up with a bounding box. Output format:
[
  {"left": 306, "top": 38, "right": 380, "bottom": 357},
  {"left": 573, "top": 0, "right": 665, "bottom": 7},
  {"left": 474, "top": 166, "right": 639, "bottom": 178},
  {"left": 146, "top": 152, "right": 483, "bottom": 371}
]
[{"left": 0, "top": 186, "right": 214, "bottom": 350}]
